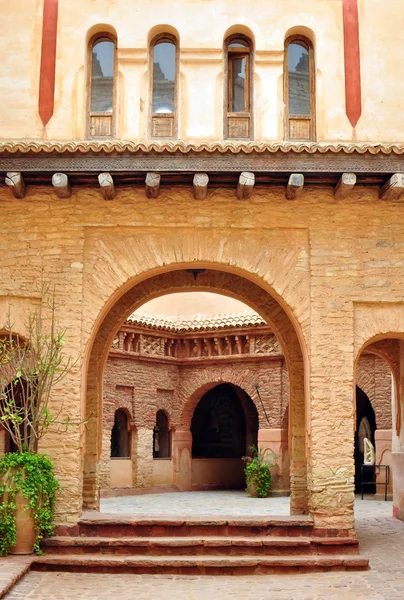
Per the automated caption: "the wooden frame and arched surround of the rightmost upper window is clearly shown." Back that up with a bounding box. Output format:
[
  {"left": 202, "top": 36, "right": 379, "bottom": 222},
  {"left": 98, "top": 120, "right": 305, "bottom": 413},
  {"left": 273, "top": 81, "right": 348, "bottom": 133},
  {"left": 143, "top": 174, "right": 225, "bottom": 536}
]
[{"left": 283, "top": 35, "right": 316, "bottom": 142}]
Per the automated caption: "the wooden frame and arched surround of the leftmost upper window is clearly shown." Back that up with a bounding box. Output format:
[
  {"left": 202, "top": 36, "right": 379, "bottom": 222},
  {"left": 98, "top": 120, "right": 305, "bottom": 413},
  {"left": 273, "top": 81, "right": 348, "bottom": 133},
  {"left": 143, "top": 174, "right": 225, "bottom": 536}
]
[{"left": 86, "top": 32, "right": 118, "bottom": 139}]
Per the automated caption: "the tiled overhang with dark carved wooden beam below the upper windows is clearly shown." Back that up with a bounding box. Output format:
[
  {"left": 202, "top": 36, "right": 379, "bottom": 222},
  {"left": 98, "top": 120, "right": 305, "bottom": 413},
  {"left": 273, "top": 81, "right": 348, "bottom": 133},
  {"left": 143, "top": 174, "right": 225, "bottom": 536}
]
[{"left": 0, "top": 140, "right": 404, "bottom": 185}]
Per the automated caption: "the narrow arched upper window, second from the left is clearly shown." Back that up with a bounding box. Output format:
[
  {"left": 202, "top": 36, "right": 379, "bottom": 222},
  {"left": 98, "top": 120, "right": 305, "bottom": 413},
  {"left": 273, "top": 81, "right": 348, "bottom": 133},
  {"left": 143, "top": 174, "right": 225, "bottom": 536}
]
[{"left": 151, "top": 34, "right": 178, "bottom": 138}]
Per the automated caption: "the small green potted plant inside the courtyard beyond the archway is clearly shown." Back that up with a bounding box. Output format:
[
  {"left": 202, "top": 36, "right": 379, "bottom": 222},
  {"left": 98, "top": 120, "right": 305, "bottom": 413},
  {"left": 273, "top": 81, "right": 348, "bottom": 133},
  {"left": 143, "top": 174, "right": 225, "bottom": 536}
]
[{"left": 244, "top": 446, "right": 275, "bottom": 498}]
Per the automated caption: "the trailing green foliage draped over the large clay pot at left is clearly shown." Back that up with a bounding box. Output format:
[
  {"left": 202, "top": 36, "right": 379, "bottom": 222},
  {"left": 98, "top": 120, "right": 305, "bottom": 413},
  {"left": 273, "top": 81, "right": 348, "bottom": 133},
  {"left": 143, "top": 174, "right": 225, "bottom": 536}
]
[{"left": 0, "top": 452, "right": 60, "bottom": 555}]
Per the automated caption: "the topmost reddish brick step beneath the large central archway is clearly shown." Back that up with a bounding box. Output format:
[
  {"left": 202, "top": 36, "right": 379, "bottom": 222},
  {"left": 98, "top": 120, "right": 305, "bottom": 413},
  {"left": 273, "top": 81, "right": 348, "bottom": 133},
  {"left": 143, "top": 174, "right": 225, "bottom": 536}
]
[{"left": 64, "top": 512, "right": 314, "bottom": 538}]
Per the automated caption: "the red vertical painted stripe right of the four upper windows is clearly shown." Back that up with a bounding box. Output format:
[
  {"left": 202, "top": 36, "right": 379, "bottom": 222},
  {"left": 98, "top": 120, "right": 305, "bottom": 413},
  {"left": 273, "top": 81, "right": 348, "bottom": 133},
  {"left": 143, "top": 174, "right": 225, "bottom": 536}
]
[{"left": 342, "top": 0, "right": 362, "bottom": 127}]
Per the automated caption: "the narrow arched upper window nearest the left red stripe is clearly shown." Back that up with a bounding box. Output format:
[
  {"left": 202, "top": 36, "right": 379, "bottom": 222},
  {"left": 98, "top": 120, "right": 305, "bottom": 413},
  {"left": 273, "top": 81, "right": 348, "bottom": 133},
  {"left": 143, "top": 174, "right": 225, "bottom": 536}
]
[{"left": 88, "top": 35, "right": 116, "bottom": 137}]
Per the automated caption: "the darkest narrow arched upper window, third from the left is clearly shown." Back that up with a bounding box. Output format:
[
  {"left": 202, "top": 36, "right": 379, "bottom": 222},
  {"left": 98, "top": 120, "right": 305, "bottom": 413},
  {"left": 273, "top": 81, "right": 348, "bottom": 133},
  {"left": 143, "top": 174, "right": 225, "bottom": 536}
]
[{"left": 224, "top": 35, "right": 252, "bottom": 138}]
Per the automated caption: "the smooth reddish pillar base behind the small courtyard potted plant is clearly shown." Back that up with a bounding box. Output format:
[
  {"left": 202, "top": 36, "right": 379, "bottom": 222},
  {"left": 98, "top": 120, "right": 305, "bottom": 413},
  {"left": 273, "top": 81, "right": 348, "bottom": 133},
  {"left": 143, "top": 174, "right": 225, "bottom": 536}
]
[{"left": 258, "top": 429, "right": 290, "bottom": 496}]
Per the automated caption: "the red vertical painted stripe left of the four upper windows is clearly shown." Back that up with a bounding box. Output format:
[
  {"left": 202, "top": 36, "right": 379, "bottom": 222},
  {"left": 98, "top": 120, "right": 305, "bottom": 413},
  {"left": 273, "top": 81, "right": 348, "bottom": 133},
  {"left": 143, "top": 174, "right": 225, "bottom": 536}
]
[{"left": 38, "top": 0, "right": 58, "bottom": 126}]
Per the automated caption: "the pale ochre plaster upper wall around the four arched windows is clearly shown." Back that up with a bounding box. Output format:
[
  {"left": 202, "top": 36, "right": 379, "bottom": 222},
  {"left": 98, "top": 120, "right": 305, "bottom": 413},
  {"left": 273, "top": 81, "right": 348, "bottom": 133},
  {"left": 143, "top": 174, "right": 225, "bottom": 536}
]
[{"left": 0, "top": 0, "right": 404, "bottom": 141}]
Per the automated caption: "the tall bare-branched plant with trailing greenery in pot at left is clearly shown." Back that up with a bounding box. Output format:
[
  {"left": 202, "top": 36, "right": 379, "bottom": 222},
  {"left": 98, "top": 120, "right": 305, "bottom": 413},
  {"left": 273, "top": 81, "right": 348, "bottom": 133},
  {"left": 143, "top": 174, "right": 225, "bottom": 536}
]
[{"left": 0, "top": 294, "right": 75, "bottom": 555}]
